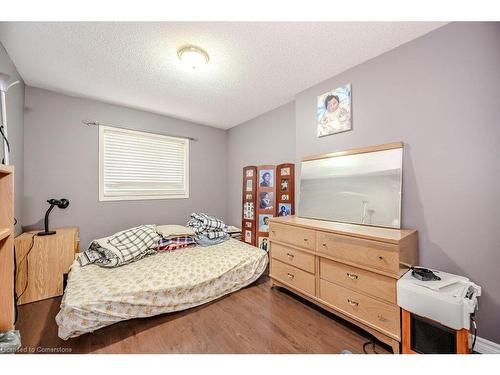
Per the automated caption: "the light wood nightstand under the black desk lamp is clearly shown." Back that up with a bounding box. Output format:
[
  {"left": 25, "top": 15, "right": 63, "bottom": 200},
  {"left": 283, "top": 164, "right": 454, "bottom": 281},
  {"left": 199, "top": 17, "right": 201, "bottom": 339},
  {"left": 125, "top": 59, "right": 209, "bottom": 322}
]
[{"left": 14, "top": 227, "right": 79, "bottom": 305}]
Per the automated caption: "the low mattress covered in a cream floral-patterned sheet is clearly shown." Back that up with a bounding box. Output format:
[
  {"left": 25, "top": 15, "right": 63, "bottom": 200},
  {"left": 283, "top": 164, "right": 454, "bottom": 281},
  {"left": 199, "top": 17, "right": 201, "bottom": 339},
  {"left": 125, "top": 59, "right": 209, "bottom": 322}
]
[{"left": 56, "top": 239, "right": 268, "bottom": 340}]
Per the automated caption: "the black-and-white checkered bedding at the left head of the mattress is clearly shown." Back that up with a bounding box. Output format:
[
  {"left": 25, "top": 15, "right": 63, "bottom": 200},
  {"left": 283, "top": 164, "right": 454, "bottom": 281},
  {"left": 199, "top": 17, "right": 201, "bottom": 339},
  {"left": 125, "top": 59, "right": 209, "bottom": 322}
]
[{"left": 77, "top": 225, "right": 160, "bottom": 268}]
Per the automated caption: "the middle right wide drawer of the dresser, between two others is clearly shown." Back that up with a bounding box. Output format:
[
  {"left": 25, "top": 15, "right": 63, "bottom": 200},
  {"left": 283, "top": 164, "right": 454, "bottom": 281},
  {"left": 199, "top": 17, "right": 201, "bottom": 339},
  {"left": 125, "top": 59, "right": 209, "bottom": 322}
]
[{"left": 319, "top": 258, "right": 396, "bottom": 304}]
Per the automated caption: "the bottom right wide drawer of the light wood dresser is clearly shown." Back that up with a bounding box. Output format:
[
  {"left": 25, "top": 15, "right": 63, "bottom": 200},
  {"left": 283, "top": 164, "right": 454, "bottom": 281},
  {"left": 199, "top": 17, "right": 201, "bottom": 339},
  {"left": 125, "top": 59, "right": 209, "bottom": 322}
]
[{"left": 319, "top": 280, "right": 401, "bottom": 338}]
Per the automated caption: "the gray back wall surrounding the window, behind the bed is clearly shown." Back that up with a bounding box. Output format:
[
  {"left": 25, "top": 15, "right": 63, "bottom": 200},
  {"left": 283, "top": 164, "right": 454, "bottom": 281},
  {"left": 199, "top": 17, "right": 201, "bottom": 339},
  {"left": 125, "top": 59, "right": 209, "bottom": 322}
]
[{"left": 23, "top": 87, "right": 226, "bottom": 248}]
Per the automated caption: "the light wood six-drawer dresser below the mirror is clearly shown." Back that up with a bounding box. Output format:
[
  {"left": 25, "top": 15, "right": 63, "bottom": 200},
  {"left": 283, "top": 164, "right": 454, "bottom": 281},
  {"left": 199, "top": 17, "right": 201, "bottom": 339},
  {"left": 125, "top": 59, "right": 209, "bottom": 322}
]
[{"left": 269, "top": 216, "right": 418, "bottom": 353}]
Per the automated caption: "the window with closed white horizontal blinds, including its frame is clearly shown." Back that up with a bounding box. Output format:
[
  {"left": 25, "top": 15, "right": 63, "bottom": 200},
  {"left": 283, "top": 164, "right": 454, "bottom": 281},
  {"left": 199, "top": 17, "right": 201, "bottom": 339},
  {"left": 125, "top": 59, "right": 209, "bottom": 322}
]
[{"left": 99, "top": 126, "right": 189, "bottom": 201}]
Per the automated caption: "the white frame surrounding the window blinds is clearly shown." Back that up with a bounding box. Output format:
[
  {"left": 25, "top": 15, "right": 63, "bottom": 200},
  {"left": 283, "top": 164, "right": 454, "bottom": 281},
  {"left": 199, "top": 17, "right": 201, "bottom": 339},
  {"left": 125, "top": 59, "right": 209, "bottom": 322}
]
[{"left": 99, "top": 125, "right": 189, "bottom": 202}]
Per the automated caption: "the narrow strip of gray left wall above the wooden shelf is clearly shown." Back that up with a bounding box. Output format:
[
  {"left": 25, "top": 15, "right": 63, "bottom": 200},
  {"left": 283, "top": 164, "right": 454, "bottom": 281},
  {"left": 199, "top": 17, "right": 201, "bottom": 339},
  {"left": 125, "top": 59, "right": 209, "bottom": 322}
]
[{"left": 0, "top": 43, "right": 24, "bottom": 234}]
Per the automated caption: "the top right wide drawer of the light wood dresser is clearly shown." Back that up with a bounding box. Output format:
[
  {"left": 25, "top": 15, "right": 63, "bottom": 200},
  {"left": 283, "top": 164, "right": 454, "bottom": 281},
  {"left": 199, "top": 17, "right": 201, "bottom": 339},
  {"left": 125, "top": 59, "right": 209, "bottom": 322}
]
[{"left": 317, "top": 232, "right": 399, "bottom": 275}]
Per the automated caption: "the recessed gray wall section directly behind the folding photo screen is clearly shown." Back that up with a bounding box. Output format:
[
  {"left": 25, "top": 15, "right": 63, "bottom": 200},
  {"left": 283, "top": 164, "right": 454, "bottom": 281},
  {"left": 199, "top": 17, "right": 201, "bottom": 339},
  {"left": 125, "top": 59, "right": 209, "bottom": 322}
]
[{"left": 227, "top": 102, "right": 295, "bottom": 227}]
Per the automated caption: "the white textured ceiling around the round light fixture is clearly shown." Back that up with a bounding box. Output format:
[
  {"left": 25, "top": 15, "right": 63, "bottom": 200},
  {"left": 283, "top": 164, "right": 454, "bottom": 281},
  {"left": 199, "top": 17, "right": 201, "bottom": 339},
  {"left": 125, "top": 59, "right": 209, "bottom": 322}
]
[{"left": 0, "top": 22, "right": 443, "bottom": 129}]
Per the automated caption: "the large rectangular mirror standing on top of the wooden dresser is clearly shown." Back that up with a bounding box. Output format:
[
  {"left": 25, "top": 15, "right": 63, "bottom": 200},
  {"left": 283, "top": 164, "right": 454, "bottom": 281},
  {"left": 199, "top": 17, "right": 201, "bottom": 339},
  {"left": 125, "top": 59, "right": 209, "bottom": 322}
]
[{"left": 298, "top": 142, "right": 403, "bottom": 229}]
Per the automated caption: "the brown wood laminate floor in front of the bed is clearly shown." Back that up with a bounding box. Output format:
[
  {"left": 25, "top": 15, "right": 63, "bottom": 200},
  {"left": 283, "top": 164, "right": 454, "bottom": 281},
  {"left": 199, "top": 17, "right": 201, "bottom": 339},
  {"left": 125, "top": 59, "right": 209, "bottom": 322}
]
[{"left": 16, "top": 276, "right": 390, "bottom": 354}]
